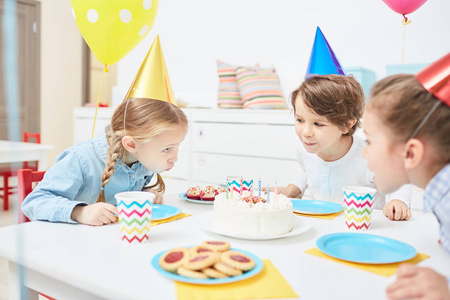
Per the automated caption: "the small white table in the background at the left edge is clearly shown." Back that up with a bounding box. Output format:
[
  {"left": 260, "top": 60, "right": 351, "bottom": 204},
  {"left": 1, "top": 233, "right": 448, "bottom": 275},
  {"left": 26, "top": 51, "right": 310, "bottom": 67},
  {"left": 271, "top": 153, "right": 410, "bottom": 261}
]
[{"left": 0, "top": 141, "right": 54, "bottom": 170}]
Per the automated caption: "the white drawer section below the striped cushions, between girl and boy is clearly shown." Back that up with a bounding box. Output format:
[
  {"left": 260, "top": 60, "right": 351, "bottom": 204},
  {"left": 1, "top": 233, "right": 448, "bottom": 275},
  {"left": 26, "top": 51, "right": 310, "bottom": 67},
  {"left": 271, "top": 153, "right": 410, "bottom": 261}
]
[{"left": 190, "top": 109, "right": 297, "bottom": 186}]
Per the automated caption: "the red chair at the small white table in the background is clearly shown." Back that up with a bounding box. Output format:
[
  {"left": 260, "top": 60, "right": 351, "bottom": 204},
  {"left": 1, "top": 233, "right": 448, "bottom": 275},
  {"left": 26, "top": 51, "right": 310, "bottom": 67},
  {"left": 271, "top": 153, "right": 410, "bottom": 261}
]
[{"left": 0, "top": 132, "right": 41, "bottom": 211}]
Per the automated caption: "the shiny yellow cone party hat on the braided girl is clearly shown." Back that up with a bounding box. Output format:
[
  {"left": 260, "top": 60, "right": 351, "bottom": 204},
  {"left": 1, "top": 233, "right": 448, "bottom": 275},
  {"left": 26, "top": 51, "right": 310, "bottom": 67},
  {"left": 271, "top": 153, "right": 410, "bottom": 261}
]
[{"left": 125, "top": 35, "right": 177, "bottom": 105}]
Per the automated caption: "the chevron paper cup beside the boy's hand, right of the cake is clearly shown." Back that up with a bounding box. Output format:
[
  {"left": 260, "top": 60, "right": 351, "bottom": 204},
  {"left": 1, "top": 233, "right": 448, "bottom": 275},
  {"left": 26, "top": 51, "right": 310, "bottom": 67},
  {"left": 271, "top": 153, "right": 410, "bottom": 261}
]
[{"left": 343, "top": 186, "right": 377, "bottom": 231}]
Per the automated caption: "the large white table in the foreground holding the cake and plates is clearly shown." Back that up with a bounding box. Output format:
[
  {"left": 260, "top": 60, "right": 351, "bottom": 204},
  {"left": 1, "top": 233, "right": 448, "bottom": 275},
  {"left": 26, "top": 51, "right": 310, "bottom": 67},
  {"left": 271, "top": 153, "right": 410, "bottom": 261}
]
[{"left": 0, "top": 196, "right": 450, "bottom": 300}]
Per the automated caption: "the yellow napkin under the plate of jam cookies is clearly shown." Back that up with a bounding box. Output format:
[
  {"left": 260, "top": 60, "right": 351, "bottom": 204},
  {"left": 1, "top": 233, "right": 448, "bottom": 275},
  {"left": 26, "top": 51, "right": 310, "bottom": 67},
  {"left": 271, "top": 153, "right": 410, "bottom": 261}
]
[{"left": 176, "top": 259, "right": 298, "bottom": 300}]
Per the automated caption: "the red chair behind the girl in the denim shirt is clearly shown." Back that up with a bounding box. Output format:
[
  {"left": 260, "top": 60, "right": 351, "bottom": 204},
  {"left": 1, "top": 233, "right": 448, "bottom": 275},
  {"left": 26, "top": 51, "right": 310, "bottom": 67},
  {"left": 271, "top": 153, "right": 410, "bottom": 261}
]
[{"left": 17, "top": 169, "right": 56, "bottom": 300}]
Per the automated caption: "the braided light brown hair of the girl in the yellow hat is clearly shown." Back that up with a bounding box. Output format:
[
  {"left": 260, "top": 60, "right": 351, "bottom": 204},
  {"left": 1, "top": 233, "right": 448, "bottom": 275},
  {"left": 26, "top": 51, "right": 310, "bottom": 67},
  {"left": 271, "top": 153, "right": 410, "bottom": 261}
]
[{"left": 97, "top": 98, "right": 188, "bottom": 202}]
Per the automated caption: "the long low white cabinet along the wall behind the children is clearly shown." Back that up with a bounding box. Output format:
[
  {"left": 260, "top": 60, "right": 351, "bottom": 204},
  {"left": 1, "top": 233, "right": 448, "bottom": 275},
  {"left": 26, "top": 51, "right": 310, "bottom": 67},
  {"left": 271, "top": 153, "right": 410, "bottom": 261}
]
[{"left": 74, "top": 107, "right": 297, "bottom": 194}]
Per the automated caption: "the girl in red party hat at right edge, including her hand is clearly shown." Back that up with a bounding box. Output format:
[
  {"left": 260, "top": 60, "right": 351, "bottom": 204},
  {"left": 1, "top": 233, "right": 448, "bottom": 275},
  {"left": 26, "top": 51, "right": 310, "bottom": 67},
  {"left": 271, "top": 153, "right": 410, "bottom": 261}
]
[{"left": 363, "top": 53, "right": 450, "bottom": 299}]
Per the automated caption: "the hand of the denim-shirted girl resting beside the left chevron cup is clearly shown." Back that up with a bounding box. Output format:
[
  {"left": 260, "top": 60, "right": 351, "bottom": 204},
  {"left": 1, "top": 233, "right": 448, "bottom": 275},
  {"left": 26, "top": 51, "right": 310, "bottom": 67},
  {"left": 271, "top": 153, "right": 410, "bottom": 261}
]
[{"left": 70, "top": 203, "right": 119, "bottom": 226}]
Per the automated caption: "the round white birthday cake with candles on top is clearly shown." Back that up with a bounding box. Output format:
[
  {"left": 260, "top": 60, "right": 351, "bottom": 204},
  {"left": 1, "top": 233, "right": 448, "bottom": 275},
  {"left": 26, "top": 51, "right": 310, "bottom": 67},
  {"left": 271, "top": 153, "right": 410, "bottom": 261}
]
[{"left": 213, "top": 191, "right": 294, "bottom": 236}]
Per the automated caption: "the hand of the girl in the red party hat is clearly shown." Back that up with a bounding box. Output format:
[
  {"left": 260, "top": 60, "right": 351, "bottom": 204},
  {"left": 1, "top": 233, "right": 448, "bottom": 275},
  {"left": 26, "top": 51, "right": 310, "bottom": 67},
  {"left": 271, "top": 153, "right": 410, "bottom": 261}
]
[{"left": 386, "top": 264, "right": 450, "bottom": 300}]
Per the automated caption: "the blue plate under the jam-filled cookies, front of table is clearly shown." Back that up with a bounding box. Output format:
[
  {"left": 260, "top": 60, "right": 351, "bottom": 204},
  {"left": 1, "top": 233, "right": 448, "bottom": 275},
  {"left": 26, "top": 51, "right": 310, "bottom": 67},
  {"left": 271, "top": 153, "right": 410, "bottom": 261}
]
[{"left": 152, "top": 247, "right": 264, "bottom": 285}]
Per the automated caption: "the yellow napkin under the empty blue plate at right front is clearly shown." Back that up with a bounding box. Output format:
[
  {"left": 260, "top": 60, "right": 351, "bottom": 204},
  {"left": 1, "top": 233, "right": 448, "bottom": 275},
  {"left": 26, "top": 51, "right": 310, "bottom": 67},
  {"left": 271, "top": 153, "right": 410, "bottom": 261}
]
[{"left": 305, "top": 248, "right": 430, "bottom": 277}]
